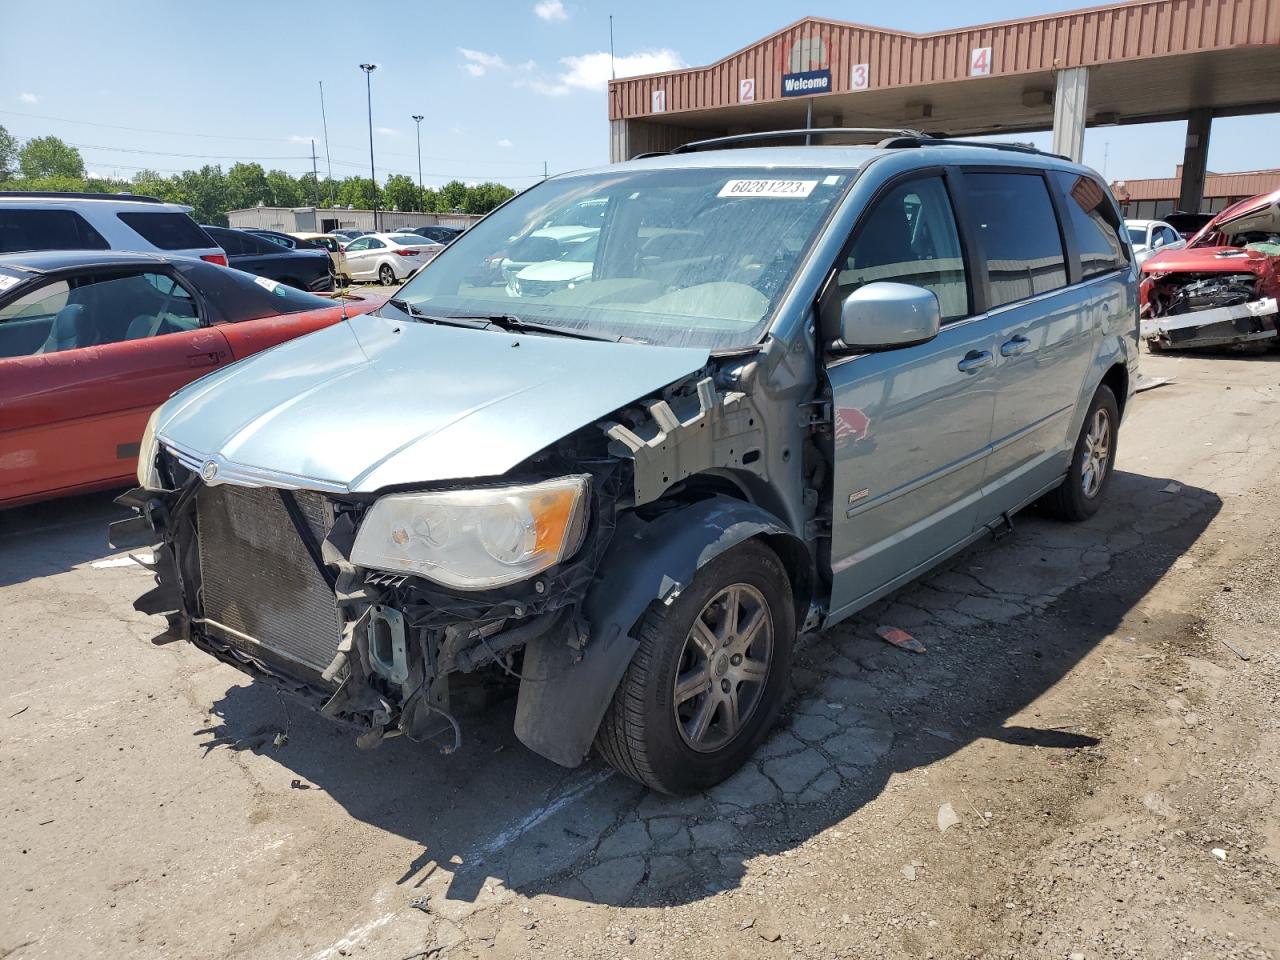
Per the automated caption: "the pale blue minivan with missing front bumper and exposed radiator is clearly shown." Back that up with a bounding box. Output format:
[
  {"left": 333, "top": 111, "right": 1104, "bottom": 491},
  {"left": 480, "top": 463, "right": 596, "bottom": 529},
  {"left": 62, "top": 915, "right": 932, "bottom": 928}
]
[{"left": 113, "top": 131, "right": 1138, "bottom": 794}]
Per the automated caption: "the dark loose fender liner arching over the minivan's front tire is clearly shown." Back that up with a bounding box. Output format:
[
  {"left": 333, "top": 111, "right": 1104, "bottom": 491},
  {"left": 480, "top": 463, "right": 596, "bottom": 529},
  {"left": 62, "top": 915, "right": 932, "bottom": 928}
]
[{"left": 516, "top": 497, "right": 808, "bottom": 767}]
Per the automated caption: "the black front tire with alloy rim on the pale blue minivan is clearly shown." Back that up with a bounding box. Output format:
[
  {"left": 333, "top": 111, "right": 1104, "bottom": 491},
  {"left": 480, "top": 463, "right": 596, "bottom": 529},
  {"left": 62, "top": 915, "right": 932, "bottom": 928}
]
[{"left": 595, "top": 540, "right": 796, "bottom": 795}]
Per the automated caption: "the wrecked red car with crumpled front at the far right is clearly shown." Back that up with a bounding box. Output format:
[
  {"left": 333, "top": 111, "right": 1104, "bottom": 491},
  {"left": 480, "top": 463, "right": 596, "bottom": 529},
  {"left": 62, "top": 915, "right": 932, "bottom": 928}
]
[{"left": 1140, "top": 191, "right": 1280, "bottom": 352}]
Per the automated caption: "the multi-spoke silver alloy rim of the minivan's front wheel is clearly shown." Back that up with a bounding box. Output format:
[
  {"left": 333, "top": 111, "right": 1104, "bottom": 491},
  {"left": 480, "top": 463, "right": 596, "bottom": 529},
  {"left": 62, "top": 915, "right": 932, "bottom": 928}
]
[{"left": 672, "top": 584, "right": 773, "bottom": 753}]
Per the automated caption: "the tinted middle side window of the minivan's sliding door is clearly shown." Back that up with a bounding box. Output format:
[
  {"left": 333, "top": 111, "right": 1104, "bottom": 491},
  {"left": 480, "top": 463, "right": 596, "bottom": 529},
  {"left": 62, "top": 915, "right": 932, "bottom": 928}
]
[{"left": 965, "top": 173, "right": 1066, "bottom": 307}]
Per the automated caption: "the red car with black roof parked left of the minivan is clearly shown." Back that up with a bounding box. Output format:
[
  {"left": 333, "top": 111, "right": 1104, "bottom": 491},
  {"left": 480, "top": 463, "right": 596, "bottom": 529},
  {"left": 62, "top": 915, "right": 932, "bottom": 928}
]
[{"left": 0, "top": 251, "right": 383, "bottom": 509}]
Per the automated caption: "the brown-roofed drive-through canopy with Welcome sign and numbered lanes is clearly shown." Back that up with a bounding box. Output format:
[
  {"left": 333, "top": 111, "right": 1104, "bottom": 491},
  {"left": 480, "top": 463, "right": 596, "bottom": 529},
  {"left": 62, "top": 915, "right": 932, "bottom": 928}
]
[{"left": 609, "top": 0, "right": 1280, "bottom": 210}]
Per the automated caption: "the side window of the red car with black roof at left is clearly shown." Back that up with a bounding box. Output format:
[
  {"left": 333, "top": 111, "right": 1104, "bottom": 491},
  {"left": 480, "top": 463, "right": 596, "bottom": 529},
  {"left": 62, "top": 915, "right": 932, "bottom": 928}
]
[{"left": 0, "top": 273, "right": 200, "bottom": 357}]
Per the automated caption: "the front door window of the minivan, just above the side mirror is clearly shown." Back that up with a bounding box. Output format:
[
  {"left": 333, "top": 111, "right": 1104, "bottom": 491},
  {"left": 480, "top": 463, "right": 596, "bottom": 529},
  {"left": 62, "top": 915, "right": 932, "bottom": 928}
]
[{"left": 836, "top": 177, "right": 970, "bottom": 321}]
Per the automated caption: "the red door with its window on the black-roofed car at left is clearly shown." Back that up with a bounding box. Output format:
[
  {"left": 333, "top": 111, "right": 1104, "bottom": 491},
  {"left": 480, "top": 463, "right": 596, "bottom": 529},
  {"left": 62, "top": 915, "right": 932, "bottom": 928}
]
[{"left": 0, "top": 269, "right": 230, "bottom": 503}]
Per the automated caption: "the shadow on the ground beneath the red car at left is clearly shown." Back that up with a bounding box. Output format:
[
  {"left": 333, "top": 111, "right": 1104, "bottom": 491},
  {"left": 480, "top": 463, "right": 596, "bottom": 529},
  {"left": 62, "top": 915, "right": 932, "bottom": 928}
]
[{"left": 0, "top": 490, "right": 129, "bottom": 586}]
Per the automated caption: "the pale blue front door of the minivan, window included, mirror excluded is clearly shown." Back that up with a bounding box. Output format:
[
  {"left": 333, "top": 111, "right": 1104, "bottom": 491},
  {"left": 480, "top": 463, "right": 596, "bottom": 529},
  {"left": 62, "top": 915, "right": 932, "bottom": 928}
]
[{"left": 823, "top": 170, "right": 996, "bottom": 617}]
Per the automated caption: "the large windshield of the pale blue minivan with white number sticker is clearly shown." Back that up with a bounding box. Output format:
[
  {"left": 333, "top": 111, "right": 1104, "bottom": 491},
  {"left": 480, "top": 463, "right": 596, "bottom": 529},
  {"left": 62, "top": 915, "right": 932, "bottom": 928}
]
[{"left": 398, "top": 168, "right": 854, "bottom": 349}]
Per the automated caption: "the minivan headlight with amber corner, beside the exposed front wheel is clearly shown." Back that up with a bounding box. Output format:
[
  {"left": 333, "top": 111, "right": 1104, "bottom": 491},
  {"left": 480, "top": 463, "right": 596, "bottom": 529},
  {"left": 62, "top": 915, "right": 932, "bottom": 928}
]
[{"left": 351, "top": 476, "right": 590, "bottom": 590}]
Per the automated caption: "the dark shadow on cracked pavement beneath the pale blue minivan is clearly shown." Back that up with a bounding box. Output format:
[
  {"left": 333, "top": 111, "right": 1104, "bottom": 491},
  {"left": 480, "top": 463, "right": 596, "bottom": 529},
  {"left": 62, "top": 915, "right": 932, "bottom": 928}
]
[{"left": 202, "top": 472, "right": 1221, "bottom": 916}]
